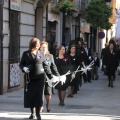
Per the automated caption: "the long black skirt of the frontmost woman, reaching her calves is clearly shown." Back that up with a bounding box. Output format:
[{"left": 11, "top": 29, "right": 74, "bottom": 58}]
[{"left": 24, "top": 79, "right": 45, "bottom": 108}]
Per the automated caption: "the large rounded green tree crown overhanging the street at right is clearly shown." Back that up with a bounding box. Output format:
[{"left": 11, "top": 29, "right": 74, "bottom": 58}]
[{"left": 86, "top": 0, "right": 112, "bottom": 29}]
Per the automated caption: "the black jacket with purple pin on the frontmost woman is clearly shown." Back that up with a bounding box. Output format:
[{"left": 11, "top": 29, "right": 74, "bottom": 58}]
[{"left": 20, "top": 50, "right": 52, "bottom": 79}]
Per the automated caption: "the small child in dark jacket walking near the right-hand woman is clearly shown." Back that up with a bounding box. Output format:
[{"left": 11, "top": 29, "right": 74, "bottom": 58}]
[{"left": 93, "top": 51, "right": 100, "bottom": 80}]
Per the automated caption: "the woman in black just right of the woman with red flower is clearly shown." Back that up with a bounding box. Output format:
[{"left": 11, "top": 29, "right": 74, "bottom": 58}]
[{"left": 68, "top": 45, "right": 81, "bottom": 97}]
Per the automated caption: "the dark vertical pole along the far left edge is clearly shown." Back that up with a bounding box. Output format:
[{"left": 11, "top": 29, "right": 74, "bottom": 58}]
[{"left": 0, "top": 0, "right": 4, "bottom": 95}]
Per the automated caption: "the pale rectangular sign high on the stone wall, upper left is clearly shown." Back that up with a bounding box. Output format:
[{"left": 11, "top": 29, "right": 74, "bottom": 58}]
[{"left": 10, "top": 0, "right": 21, "bottom": 11}]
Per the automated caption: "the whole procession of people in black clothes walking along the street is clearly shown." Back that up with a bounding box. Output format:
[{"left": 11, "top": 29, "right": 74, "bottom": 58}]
[{"left": 20, "top": 38, "right": 119, "bottom": 120}]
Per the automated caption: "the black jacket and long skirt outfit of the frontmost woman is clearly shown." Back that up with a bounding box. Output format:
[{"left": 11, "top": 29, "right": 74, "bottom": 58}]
[{"left": 20, "top": 50, "right": 52, "bottom": 108}]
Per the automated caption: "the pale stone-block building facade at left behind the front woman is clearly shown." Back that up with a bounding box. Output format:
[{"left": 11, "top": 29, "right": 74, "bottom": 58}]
[{"left": 0, "top": 0, "right": 50, "bottom": 94}]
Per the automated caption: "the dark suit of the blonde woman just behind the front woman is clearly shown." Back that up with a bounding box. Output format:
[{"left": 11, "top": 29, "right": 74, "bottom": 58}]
[{"left": 44, "top": 54, "right": 59, "bottom": 95}]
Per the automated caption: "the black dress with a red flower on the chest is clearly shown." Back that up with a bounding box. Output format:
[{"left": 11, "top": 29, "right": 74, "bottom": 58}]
[{"left": 55, "top": 55, "right": 70, "bottom": 90}]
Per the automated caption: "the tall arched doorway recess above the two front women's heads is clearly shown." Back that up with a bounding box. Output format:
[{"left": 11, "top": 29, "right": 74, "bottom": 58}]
[{"left": 34, "top": 0, "right": 50, "bottom": 41}]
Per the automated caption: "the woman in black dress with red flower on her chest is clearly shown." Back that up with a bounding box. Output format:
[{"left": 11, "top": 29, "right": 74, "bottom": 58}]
[{"left": 55, "top": 46, "right": 70, "bottom": 106}]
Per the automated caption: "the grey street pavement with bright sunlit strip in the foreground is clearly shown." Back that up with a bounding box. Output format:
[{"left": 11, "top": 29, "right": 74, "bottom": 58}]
[{"left": 0, "top": 70, "right": 120, "bottom": 120}]
